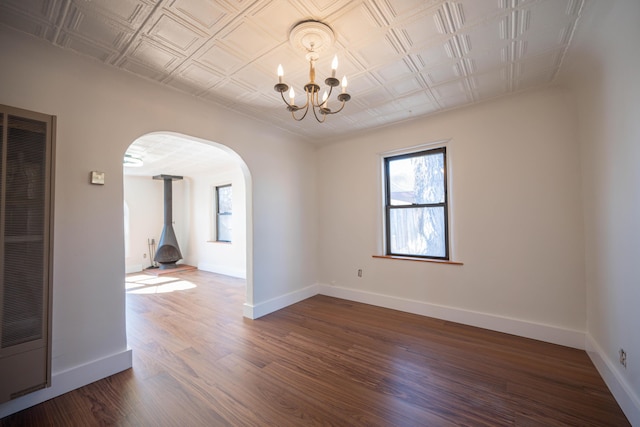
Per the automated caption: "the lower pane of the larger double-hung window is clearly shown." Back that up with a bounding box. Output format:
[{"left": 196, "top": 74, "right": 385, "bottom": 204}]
[{"left": 389, "top": 207, "right": 447, "bottom": 257}]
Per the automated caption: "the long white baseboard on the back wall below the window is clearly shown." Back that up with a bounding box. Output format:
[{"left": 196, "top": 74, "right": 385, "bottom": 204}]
[{"left": 318, "top": 284, "right": 585, "bottom": 350}]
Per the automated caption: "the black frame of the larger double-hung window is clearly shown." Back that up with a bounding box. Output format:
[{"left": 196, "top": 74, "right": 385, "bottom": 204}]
[{"left": 384, "top": 146, "right": 451, "bottom": 261}]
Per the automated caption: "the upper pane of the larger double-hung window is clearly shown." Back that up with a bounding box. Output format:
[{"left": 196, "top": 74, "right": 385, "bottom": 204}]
[{"left": 389, "top": 153, "right": 445, "bottom": 206}]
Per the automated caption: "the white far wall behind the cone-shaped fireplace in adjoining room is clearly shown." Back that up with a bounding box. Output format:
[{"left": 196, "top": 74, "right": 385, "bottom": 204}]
[{"left": 124, "top": 176, "right": 191, "bottom": 273}]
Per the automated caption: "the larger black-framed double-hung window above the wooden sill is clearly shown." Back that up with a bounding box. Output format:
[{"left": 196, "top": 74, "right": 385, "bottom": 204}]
[{"left": 384, "top": 147, "right": 449, "bottom": 260}]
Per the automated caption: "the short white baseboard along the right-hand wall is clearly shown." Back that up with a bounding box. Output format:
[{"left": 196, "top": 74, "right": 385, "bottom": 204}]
[{"left": 586, "top": 334, "right": 640, "bottom": 426}]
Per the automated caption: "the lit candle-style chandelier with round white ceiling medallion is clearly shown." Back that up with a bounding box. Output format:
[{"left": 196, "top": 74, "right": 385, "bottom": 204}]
[{"left": 273, "top": 21, "right": 351, "bottom": 123}]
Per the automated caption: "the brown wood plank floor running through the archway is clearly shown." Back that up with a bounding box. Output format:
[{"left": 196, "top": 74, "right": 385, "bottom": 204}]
[{"left": 0, "top": 271, "right": 629, "bottom": 426}]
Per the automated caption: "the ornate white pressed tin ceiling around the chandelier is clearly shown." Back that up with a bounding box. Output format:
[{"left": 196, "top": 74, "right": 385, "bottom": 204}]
[{"left": 0, "top": 0, "right": 585, "bottom": 142}]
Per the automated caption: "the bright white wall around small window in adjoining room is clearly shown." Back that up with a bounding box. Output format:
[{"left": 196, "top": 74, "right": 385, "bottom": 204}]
[{"left": 186, "top": 165, "right": 247, "bottom": 278}]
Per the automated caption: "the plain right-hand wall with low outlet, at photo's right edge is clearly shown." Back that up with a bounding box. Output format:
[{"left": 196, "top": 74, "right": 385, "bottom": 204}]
[{"left": 567, "top": 0, "right": 640, "bottom": 425}]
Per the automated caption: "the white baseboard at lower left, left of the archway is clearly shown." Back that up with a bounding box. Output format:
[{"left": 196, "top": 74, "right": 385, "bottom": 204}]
[{"left": 0, "top": 349, "right": 133, "bottom": 418}]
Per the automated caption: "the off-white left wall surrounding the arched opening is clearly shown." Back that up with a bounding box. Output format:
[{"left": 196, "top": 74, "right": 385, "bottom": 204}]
[{"left": 0, "top": 27, "right": 317, "bottom": 416}]
